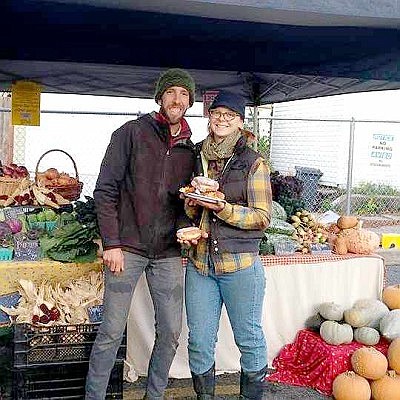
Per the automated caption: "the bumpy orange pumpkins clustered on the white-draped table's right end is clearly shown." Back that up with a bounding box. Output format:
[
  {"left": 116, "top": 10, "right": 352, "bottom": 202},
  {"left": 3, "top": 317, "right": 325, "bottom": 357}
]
[{"left": 330, "top": 215, "right": 380, "bottom": 255}]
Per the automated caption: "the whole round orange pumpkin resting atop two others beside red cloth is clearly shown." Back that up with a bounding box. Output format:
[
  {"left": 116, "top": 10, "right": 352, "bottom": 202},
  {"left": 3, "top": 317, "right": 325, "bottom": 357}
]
[{"left": 351, "top": 347, "right": 388, "bottom": 380}]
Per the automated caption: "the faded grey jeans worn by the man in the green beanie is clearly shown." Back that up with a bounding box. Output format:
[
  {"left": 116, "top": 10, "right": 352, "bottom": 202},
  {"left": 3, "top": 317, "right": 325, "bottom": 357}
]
[{"left": 86, "top": 252, "right": 183, "bottom": 400}]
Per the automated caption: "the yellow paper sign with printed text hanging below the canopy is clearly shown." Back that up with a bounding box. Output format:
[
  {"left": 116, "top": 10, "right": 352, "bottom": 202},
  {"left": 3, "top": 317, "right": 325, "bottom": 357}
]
[{"left": 11, "top": 81, "right": 41, "bottom": 126}]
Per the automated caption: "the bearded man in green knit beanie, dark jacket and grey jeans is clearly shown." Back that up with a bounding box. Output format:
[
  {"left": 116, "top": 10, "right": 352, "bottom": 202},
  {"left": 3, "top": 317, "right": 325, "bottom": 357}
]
[{"left": 86, "top": 69, "right": 195, "bottom": 400}]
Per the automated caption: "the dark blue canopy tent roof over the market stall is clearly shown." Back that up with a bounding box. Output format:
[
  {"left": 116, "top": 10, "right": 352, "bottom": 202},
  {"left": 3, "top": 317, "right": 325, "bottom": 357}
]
[{"left": 0, "top": 0, "right": 400, "bottom": 105}]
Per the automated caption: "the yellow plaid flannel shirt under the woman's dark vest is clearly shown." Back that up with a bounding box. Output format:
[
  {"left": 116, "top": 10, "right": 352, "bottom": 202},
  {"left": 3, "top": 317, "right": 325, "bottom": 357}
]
[{"left": 188, "top": 157, "right": 272, "bottom": 275}]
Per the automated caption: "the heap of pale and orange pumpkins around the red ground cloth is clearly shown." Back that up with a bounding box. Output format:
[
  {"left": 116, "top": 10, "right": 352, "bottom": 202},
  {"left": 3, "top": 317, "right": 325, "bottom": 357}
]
[{"left": 306, "top": 285, "right": 400, "bottom": 400}]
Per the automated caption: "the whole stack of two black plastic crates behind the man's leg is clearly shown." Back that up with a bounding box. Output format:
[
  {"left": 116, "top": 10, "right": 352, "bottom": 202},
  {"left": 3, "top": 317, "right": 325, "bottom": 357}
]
[{"left": 12, "top": 324, "right": 126, "bottom": 400}]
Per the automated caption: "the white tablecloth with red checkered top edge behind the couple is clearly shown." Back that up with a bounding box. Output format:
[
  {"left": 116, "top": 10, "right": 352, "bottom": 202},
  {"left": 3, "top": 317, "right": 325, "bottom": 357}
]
[{"left": 126, "top": 254, "right": 384, "bottom": 381}]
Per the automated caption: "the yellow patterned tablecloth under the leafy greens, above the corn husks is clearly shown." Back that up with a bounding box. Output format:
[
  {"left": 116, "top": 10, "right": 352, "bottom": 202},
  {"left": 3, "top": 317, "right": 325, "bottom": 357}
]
[{"left": 0, "top": 259, "right": 102, "bottom": 294}]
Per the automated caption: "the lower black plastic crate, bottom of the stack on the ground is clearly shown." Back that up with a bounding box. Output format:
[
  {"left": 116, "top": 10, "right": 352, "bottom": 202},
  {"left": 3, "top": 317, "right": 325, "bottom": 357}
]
[{"left": 12, "top": 361, "right": 124, "bottom": 400}]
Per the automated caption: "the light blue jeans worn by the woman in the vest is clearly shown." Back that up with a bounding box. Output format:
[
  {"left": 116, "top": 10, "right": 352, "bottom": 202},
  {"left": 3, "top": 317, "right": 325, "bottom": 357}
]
[{"left": 185, "top": 257, "right": 267, "bottom": 375}]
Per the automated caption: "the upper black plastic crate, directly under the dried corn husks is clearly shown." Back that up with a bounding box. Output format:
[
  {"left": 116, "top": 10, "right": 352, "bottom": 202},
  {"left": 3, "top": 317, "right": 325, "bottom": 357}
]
[{"left": 13, "top": 324, "right": 126, "bottom": 368}]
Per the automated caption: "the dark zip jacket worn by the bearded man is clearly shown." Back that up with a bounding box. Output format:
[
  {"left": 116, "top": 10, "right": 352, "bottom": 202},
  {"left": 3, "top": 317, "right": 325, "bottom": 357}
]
[{"left": 94, "top": 114, "right": 195, "bottom": 258}]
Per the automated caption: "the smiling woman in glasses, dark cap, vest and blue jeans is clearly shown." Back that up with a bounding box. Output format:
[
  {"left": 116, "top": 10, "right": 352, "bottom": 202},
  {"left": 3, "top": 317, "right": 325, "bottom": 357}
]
[{"left": 181, "top": 91, "right": 272, "bottom": 399}]
